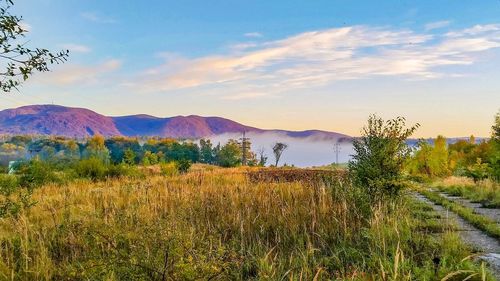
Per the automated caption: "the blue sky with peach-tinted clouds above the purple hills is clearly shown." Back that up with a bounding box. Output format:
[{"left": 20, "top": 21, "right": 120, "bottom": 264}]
[{"left": 0, "top": 0, "right": 500, "bottom": 137}]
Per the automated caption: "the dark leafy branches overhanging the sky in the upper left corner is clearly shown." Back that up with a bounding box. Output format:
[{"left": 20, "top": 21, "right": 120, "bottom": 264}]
[{"left": 0, "top": 0, "right": 69, "bottom": 92}]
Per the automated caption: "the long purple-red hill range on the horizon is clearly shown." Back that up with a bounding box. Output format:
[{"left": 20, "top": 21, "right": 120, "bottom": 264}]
[{"left": 0, "top": 105, "right": 350, "bottom": 140}]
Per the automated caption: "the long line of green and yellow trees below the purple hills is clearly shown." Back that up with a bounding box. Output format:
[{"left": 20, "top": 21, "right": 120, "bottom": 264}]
[{"left": 0, "top": 135, "right": 288, "bottom": 170}]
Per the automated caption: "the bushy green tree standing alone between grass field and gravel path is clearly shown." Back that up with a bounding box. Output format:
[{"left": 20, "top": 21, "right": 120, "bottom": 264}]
[{"left": 349, "top": 115, "right": 419, "bottom": 202}]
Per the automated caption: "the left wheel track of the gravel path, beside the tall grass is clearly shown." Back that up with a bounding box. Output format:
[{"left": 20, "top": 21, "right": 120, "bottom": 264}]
[{"left": 415, "top": 191, "right": 500, "bottom": 280}]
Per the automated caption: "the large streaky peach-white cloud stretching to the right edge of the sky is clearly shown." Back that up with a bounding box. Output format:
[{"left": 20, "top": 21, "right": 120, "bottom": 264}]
[{"left": 132, "top": 25, "right": 500, "bottom": 99}]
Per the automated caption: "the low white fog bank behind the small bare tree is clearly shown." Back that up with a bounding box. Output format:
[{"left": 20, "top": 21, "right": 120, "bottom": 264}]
[{"left": 210, "top": 133, "right": 353, "bottom": 167}]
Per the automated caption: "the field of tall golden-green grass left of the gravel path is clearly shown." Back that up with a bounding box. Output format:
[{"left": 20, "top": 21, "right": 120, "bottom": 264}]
[{"left": 0, "top": 166, "right": 492, "bottom": 280}]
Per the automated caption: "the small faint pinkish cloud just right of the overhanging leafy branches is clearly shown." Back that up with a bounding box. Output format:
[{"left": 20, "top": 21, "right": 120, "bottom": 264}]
[{"left": 35, "top": 59, "right": 122, "bottom": 86}]
